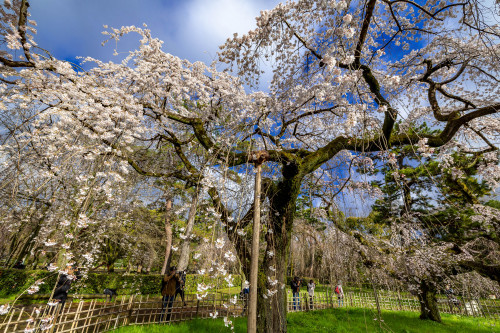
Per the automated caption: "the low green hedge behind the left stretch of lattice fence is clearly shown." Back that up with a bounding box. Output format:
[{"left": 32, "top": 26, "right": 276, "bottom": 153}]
[{"left": 0, "top": 269, "right": 241, "bottom": 297}]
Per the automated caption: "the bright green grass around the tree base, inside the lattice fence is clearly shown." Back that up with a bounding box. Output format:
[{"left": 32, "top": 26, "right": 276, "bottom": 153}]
[{"left": 113, "top": 308, "right": 500, "bottom": 333}]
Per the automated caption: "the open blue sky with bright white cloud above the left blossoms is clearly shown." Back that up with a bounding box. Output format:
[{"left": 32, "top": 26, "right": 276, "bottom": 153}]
[{"left": 30, "top": 0, "right": 279, "bottom": 63}]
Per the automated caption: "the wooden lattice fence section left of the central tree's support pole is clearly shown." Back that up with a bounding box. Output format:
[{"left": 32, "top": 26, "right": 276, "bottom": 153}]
[{"left": 0, "top": 293, "right": 245, "bottom": 333}]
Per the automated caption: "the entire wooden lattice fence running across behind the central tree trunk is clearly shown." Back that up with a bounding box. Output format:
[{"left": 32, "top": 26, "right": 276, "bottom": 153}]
[{"left": 0, "top": 291, "right": 500, "bottom": 333}]
